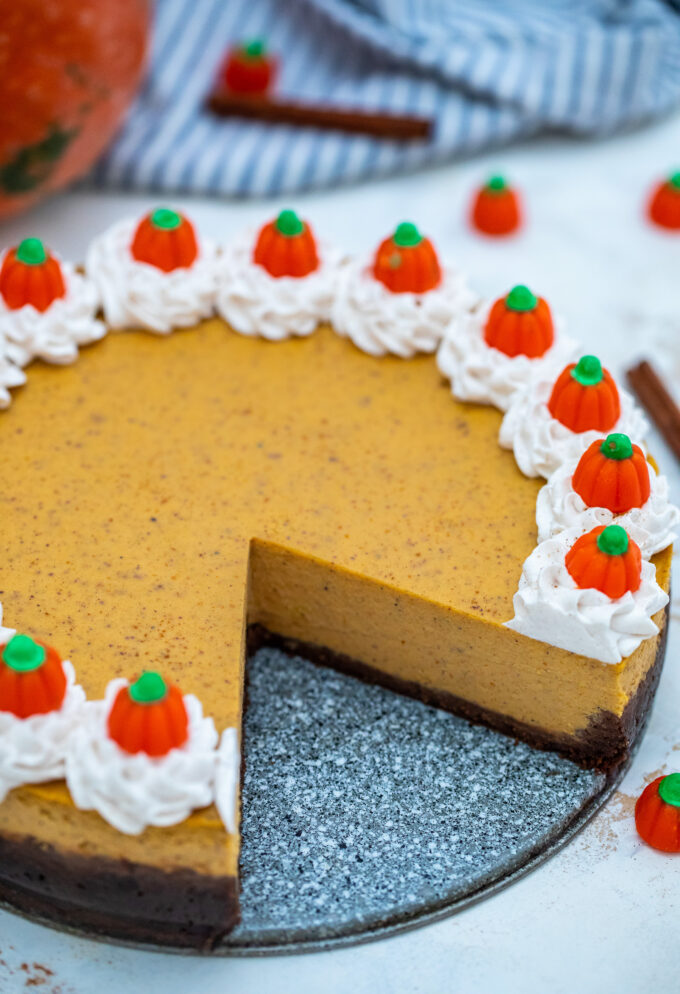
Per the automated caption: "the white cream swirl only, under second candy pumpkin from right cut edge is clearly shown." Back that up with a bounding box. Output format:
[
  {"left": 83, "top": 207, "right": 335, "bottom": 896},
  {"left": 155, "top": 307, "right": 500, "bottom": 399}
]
[{"left": 536, "top": 459, "right": 680, "bottom": 559}]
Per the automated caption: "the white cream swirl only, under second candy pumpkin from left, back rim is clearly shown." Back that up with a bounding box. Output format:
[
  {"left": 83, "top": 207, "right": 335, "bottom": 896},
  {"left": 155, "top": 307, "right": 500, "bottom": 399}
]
[{"left": 85, "top": 218, "right": 219, "bottom": 335}]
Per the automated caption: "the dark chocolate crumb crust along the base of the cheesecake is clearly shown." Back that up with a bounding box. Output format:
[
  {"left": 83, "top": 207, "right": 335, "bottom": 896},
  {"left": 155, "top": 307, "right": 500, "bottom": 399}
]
[{"left": 0, "top": 600, "right": 668, "bottom": 952}]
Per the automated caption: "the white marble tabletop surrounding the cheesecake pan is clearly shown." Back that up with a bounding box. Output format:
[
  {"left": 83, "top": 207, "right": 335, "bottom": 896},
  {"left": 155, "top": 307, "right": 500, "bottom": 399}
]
[{"left": 0, "top": 116, "right": 680, "bottom": 994}]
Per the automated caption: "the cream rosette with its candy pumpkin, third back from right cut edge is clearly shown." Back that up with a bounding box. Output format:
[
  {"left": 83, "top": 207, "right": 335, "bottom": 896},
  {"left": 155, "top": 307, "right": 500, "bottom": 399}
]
[{"left": 498, "top": 356, "right": 648, "bottom": 479}]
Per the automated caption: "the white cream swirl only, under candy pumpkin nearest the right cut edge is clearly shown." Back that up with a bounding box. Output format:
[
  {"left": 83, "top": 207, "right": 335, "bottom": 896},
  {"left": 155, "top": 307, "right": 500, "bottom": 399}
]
[{"left": 505, "top": 528, "right": 668, "bottom": 664}]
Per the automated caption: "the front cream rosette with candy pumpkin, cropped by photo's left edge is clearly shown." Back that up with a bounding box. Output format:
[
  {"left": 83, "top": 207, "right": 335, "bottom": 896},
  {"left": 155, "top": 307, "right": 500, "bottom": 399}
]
[{"left": 0, "top": 628, "right": 85, "bottom": 801}]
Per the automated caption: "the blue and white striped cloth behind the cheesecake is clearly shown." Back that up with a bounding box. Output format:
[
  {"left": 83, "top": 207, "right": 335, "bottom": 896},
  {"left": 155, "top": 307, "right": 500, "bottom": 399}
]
[{"left": 93, "top": 0, "right": 680, "bottom": 196}]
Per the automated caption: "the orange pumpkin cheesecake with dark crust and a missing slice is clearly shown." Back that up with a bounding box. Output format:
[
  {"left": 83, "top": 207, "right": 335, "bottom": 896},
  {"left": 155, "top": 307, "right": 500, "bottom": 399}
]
[{"left": 0, "top": 218, "right": 671, "bottom": 949}]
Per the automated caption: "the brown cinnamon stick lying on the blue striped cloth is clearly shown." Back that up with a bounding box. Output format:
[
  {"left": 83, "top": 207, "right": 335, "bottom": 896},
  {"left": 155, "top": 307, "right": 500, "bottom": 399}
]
[{"left": 207, "top": 90, "right": 432, "bottom": 141}]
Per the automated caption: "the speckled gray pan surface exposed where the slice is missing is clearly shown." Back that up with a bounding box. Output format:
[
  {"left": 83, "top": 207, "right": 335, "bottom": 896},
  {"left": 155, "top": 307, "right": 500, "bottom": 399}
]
[{"left": 223, "top": 649, "right": 611, "bottom": 952}]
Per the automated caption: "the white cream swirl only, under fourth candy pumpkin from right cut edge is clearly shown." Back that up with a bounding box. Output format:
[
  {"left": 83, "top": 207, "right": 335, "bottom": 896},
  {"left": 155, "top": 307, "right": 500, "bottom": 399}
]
[{"left": 437, "top": 301, "right": 578, "bottom": 411}]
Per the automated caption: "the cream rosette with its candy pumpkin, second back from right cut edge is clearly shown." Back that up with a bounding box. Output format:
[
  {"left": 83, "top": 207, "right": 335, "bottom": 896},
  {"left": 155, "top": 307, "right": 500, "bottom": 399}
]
[{"left": 536, "top": 433, "right": 680, "bottom": 559}]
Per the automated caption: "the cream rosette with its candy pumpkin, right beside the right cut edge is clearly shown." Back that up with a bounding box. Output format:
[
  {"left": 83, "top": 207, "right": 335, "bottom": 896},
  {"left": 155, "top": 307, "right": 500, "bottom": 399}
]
[{"left": 506, "top": 525, "right": 668, "bottom": 663}]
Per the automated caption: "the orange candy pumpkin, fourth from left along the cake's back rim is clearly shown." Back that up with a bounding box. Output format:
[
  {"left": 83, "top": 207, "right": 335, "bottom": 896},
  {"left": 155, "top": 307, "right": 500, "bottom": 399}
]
[{"left": 373, "top": 221, "right": 442, "bottom": 293}]
